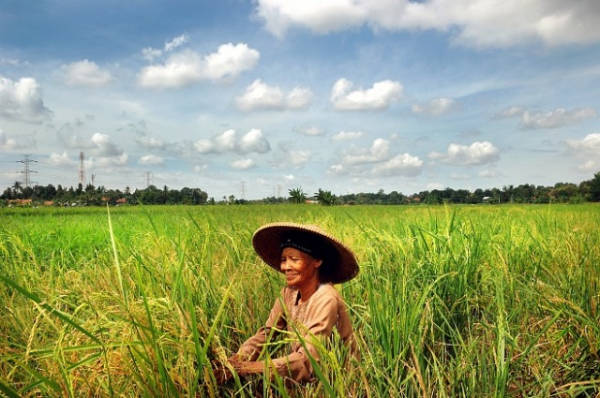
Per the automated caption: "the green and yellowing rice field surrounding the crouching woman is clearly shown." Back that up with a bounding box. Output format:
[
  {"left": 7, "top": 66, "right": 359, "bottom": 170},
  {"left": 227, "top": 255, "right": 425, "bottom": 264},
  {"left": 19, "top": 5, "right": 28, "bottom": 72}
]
[{"left": 0, "top": 204, "right": 600, "bottom": 397}]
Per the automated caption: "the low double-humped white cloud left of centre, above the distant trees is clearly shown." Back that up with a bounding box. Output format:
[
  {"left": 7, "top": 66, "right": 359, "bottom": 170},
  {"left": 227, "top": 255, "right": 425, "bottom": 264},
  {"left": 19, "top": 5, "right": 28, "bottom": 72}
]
[{"left": 194, "top": 129, "right": 271, "bottom": 154}]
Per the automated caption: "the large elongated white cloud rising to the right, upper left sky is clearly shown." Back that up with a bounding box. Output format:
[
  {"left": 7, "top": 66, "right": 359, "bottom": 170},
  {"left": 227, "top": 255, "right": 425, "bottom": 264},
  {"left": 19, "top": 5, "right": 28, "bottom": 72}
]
[{"left": 138, "top": 43, "right": 260, "bottom": 89}]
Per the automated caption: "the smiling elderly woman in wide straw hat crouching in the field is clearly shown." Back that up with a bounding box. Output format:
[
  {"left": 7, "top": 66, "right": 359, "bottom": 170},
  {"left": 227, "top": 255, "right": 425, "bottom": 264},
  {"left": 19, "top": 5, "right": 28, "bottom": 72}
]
[{"left": 216, "top": 223, "right": 358, "bottom": 384}]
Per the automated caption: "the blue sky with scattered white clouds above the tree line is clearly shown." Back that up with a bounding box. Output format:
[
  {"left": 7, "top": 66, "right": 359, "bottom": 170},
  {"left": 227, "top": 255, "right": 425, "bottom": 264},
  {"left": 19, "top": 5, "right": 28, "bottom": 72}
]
[{"left": 0, "top": 0, "right": 600, "bottom": 200}]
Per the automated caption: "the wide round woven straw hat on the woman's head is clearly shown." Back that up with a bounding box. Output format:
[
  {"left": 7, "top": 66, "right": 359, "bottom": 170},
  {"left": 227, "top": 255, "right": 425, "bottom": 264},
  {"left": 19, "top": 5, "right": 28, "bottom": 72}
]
[{"left": 252, "top": 222, "right": 359, "bottom": 283}]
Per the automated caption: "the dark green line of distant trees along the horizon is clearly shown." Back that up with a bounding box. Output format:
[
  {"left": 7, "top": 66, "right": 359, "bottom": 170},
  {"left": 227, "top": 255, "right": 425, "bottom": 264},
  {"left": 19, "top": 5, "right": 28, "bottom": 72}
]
[{"left": 0, "top": 172, "right": 600, "bottom": 206}]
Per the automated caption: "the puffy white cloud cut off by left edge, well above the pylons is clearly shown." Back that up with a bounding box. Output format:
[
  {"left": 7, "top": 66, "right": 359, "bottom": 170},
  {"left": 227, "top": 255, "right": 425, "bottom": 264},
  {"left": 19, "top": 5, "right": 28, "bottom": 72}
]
[{"left": 0, "top": 76, "right": 52, "bottom": 123}]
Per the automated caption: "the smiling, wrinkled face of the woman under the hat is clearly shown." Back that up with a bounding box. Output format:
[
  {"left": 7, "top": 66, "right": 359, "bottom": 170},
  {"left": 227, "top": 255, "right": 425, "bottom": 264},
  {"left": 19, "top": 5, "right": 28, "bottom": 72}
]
[{"left": 281, "top": 247, "right": 323, "bottom": 288}]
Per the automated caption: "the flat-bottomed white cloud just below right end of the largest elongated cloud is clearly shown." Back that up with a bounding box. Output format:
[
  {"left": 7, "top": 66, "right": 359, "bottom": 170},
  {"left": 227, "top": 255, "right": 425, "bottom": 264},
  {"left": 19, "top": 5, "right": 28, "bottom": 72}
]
[{"left": 236, "top": 79, "right": 313, "bottom": 112}]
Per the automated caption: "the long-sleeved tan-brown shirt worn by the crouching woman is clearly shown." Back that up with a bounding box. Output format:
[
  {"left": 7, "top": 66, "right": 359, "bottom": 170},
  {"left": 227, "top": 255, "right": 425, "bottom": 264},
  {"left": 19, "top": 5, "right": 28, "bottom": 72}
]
[{"left": 238, "top": 284, "right": 356, "bottom": 382}]
